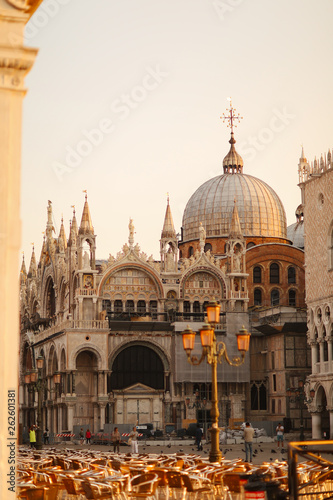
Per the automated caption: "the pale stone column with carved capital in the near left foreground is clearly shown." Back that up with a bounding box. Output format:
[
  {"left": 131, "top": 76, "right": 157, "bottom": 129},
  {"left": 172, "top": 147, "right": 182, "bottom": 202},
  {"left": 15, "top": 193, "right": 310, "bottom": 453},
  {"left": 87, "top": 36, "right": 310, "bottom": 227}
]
[{"left": 0, "top": 0, "right": 41, "bottom": 499}]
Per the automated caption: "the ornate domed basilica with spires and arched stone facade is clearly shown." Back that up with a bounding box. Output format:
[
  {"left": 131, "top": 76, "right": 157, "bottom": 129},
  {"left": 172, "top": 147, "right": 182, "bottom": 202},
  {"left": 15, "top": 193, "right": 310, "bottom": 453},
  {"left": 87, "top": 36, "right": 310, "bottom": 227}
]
[{"left": 20, "top": 120, "right": 310, "bottom": 438}]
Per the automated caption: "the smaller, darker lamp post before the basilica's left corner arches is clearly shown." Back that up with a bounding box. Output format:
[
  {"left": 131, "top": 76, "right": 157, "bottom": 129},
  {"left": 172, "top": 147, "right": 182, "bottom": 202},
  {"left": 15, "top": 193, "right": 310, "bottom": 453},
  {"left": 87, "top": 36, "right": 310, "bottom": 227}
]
[{"left": 24, "top": 356, "right": 61, "bottom": 450}]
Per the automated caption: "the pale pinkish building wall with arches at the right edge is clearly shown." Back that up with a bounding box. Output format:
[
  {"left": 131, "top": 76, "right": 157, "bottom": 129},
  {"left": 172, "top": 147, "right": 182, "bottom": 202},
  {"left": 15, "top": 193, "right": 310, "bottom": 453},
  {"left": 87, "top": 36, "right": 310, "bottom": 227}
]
[{"left": 300, "top": 161, "right": 333, "bottom": 439}]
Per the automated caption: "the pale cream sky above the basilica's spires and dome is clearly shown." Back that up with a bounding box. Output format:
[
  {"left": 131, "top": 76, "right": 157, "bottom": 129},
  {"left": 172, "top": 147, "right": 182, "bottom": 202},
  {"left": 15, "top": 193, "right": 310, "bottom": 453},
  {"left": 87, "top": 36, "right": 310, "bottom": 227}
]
[{"left": 21, "top": 0, "right": 333, "bottom": 265}]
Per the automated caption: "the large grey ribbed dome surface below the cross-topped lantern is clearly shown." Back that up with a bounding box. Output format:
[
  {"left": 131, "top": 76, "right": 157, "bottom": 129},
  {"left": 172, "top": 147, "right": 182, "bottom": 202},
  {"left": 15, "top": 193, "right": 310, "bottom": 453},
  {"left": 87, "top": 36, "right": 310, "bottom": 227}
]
[{"left": 182, "top": 172, "right": 287, "bottom": 243}]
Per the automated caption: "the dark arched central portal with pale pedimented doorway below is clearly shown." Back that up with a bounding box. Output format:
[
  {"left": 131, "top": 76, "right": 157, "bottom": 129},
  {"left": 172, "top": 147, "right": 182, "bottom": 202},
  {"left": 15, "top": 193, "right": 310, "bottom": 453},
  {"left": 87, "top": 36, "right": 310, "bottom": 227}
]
[{"left": 108, "top": 344, "right": 165, "bottom": 428}]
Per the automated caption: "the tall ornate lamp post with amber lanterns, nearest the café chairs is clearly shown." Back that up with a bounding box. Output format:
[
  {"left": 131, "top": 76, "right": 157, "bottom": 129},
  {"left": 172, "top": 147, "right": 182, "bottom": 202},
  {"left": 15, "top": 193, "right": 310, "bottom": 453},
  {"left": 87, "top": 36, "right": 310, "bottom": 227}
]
[{"left": 182, "top": 300, "right": 251, "bottom": 462}]
